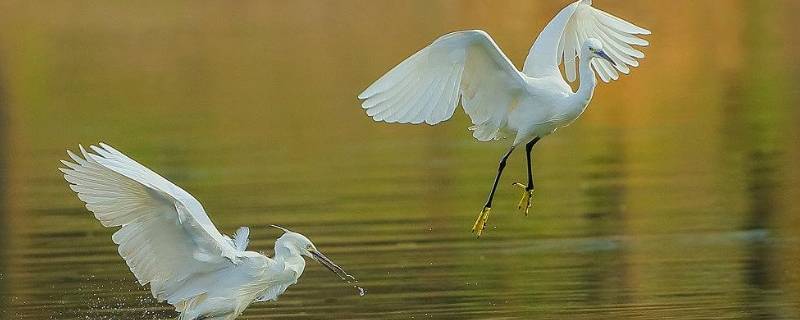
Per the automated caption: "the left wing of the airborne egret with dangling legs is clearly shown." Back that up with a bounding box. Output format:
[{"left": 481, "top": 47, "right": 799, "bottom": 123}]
[{"left": 358, "top": 30, "right": 526, "bottom": 140}]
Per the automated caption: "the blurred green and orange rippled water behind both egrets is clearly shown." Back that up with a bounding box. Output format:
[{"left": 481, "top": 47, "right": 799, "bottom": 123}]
[{"left": 0, "top": 0, "right": 800, "bottom": 319}]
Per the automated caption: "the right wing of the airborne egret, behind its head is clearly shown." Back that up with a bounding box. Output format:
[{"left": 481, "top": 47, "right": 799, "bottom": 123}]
[{"left": 522, "top": 0, "right": 650, "bottom": 82}]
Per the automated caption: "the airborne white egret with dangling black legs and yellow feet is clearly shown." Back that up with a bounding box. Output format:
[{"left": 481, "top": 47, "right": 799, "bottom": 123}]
[{"left": 358, "top": 0, "right": 650, "bottom": 237}]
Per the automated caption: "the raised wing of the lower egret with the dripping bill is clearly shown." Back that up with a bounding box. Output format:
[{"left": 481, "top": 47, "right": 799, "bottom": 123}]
[{"left": 61, "top": 143, "right": 240, "bottom": 303}]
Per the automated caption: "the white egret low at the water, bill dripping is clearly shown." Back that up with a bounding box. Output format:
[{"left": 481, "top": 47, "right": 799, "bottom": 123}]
[{"left": 60, "top": 143, "right": 360, "bottom": 320}]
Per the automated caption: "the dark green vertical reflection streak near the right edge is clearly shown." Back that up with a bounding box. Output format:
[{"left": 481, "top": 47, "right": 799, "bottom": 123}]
[{"left": 726, "top": 3, "right": 789, "bottom": 319}]
